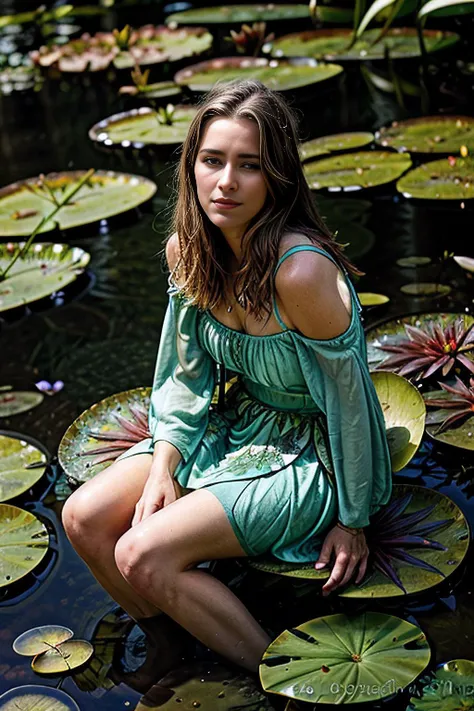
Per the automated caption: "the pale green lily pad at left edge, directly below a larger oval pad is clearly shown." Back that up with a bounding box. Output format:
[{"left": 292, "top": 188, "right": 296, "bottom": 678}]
[{"left": 0, "top": 243, "right": 90, "bottom": 312}]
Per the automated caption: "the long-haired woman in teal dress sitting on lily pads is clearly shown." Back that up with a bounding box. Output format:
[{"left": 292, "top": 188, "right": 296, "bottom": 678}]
[{"left": 63, "top": 81, "right": 391, "bottom": 678}]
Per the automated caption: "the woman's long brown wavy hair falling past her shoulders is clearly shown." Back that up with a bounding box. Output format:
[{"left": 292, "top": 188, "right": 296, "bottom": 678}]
[{"left": 171, "top": 80, "right": 361, "bottom": 319}]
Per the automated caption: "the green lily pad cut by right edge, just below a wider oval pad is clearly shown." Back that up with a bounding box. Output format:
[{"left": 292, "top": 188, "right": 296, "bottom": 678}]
[{"left": 397, "top": 157, "right": 474, "bottom": 200}]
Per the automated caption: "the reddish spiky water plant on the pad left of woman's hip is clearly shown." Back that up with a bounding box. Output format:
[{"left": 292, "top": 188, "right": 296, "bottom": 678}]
[{"left": 79, "top": 405, "right": 151, "bottom": 466}]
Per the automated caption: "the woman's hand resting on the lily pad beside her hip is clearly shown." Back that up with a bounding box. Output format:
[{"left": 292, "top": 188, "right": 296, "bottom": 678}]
[{"left": 314, "top": 526, "right": 369, "bottom": 596}]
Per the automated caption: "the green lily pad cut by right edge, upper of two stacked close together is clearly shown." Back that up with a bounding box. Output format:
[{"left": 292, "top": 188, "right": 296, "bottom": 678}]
[{"left": 375, "top": 116, "right": 474, "bottom": 153}]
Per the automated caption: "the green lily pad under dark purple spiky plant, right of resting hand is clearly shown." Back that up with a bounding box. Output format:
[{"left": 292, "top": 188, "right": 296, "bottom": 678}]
[{"left": 339, "top": 484, "right": 469, "bottom": 599}]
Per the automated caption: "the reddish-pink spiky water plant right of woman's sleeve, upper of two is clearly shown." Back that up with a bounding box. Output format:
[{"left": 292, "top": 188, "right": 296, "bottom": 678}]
[{"left": 376, "top": 318, "right": 474, "bottom": 380}]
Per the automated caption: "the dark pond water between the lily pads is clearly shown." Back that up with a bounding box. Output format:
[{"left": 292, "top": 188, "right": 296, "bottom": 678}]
[{"left": 0, "top": 5, "right": 474, "bottom": 711}]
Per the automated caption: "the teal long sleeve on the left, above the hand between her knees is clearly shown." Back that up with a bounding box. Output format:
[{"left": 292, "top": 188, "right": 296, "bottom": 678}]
[{"left": 149, "top": 288, "right": 215, "bottom": 461}]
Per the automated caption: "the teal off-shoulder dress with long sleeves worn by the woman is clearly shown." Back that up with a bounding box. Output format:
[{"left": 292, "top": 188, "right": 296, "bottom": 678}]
[{"left": 123, "top": 245, "right": 391, "bottom": 563}]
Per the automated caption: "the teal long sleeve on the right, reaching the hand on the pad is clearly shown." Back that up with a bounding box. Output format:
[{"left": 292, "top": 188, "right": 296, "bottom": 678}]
[{"left": 294, "top": 318, "right": 392, "bottom": 527}]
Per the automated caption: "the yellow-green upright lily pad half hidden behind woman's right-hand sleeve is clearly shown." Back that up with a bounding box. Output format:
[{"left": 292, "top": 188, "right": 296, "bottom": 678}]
[{"left": 371, "top": 372, "right": 426, "bottom": 472}]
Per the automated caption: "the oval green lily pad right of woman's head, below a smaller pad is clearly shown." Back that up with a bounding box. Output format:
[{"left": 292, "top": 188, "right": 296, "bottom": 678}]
[{"left": 304, "top": 151, "right": 412, "bottom": 190}]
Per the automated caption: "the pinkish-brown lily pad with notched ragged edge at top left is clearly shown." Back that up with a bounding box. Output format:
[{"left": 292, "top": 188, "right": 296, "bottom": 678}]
[{"left": 30, "top": 25, "right": 213, "bottom": 72}]
